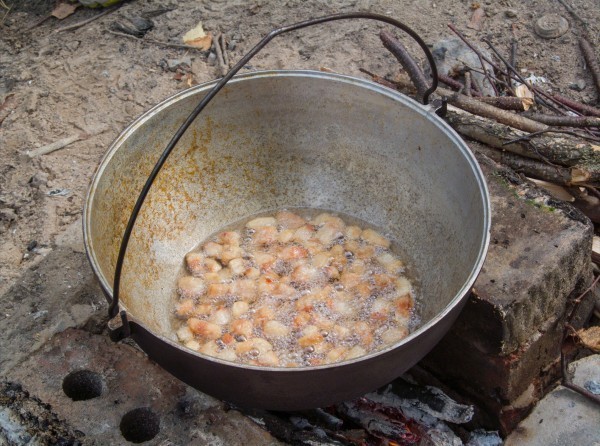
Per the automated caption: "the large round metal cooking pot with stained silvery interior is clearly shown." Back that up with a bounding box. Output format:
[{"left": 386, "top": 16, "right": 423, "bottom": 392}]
[{"left": 84, "top": 14, "right": 490, "bottom": 410}]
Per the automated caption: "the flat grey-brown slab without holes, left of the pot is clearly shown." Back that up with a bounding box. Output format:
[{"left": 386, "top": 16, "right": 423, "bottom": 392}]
[{"left": 0, "top": 246, "right": 107, "bottom": 376}]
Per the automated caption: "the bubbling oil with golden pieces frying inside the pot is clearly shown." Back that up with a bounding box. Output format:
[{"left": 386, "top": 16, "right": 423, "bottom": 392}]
[{"left": 174, "top": 208, "right": 419, "bottom": 367}]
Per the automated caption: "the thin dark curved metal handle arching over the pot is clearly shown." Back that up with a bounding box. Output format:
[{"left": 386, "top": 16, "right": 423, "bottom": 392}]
[{"left": 108, "top": 12, "right": 438, "bottom": 322}]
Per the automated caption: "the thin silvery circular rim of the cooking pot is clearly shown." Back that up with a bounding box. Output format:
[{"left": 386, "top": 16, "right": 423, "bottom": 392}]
[{"left": 82, "top": 69, "right": 491, "bottom": 373}]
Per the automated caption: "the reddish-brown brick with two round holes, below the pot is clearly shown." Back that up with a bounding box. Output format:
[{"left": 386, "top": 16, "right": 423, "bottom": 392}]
[{"left": 7, "top": 329, "right": 281, "bottom": 446}]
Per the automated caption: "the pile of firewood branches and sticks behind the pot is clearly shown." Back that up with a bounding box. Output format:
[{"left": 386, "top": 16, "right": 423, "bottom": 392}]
[{"left": 361, "top": 24, "right": 600, "bottom": 233}]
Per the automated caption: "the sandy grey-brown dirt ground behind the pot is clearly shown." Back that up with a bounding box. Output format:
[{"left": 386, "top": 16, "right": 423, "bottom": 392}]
[{"left": 0, "top": 0, "right": 600, "bottom": 295}]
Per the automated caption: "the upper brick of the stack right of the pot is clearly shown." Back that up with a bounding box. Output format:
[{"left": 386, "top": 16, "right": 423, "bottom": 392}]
[{"left": 454, "top": 153, "right": 593, "bottom": 355}]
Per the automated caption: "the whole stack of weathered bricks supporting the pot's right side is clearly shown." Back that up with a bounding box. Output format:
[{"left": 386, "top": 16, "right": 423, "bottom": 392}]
[{"left": 419, "top": 152, "right": 593, "bottom": 434}]
